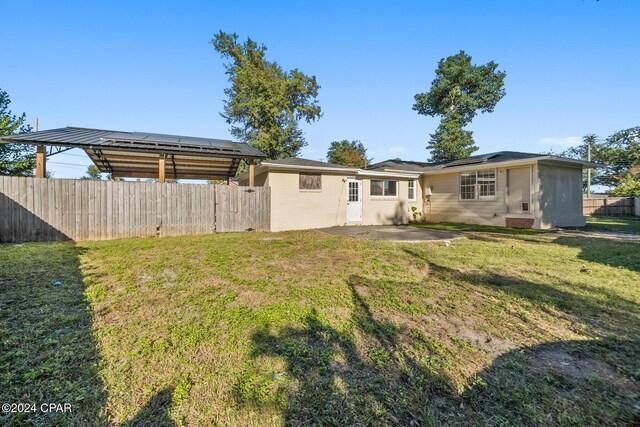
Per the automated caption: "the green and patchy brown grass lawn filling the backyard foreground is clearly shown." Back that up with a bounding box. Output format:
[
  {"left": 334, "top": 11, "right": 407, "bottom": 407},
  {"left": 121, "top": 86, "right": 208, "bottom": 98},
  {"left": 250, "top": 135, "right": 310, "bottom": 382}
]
[{"left": 0, "top": 231, "right": 640, "bottom": 426}]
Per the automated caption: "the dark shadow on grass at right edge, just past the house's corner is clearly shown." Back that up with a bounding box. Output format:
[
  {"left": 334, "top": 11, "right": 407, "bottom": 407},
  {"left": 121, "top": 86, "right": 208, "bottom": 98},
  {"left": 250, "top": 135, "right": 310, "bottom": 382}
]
[{"left": 554, "top": 236, "right": 640, "bottom": 271}]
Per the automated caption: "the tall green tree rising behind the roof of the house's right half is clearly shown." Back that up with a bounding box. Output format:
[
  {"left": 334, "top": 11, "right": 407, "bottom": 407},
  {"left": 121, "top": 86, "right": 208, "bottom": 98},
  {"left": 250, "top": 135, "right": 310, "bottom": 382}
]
[{"left": 413, "top": 50, "right": 506, "bottom": 161}]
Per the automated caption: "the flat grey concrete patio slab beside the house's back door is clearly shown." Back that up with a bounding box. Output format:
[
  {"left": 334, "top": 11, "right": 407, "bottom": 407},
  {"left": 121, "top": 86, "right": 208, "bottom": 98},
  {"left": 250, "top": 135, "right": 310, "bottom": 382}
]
[{"left": 318, "top": 225, "right": 462, "bottom": 242}]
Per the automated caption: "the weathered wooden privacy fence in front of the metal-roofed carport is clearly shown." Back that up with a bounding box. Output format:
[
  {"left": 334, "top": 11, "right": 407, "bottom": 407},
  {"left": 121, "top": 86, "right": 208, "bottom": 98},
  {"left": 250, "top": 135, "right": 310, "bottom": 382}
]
[{"left": 0, "top": 176, "right": 271, "bottom": 242}]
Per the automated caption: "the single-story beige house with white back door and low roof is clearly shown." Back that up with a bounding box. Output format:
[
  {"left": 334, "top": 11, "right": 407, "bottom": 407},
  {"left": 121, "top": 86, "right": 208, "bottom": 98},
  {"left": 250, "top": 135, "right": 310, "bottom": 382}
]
[{"left": 238, "top": 151, "right": 597, "bottom": 231}]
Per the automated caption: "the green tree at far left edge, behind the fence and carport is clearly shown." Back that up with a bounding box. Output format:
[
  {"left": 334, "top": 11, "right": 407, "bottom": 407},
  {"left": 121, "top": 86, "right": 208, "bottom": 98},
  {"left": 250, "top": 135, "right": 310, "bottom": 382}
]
[{"left": 0, "top": 89, "right": 35, "bottom": 176}]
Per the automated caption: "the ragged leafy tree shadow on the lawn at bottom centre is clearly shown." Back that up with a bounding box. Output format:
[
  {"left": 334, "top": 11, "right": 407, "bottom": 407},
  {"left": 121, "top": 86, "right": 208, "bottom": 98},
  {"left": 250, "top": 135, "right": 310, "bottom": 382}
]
[{"left": 250, "top": 276, "right": 446, "bottom": 425}]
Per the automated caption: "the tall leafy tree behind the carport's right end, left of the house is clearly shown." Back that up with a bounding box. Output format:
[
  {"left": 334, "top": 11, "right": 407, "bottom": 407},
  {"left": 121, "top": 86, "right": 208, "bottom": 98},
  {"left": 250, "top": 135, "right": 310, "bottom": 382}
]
[{"left": 211, "top": 31, "right": 322, "bottom": 159}]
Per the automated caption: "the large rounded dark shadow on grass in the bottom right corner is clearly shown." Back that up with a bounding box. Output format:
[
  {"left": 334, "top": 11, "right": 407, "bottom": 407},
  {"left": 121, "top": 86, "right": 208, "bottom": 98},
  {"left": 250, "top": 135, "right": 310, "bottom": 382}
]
[{"left": 463, "top": 339, "right": 640, "bottom": 425}]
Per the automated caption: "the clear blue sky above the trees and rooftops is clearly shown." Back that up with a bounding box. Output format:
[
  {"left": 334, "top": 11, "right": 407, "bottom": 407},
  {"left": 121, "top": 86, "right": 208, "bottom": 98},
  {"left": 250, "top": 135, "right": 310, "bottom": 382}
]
[{"left": 0, "top": 0, "right": 640, "bottom": 178}]
